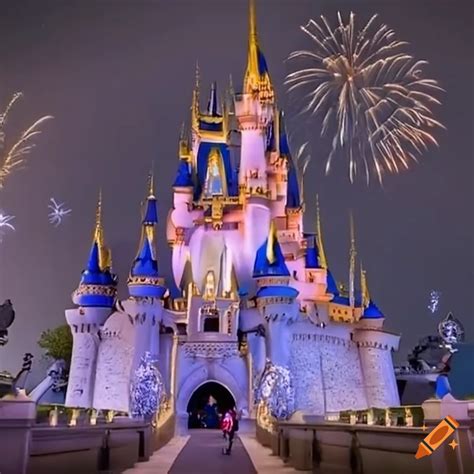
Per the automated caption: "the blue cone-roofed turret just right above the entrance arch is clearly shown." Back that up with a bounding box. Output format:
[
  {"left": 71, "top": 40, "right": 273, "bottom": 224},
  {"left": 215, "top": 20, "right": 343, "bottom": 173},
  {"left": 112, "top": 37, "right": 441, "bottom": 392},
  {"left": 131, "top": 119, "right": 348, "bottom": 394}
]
[{"left": 253, "top": 221, "right": 299, "bottom": 367}]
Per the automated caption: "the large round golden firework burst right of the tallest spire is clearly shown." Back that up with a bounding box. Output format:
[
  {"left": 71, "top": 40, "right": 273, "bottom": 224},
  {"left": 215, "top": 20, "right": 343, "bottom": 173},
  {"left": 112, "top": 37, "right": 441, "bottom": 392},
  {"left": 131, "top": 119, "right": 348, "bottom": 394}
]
[{"left": 286, "top": 13, "right": 444, "bottom": 183}]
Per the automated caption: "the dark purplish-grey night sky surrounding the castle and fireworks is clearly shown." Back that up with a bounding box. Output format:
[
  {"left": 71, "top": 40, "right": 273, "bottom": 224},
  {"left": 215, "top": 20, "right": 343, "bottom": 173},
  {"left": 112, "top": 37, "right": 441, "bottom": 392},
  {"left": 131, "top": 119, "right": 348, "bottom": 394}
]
[{"left": 0, "top": 0, "right": 474, "bottom": 378}]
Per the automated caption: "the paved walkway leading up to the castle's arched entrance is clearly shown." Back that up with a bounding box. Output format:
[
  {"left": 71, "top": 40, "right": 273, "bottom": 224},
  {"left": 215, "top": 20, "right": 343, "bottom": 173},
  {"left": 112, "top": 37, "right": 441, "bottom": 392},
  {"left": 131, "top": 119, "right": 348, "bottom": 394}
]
[{"left": 123, "top": 430, "right": 302, "bottom": 474}]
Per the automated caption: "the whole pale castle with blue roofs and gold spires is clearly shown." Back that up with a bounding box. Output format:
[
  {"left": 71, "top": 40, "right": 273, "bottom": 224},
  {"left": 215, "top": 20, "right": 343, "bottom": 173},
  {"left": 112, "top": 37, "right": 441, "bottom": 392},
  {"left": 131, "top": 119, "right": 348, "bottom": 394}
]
[{"left": 66, "top": 0, "right": 400, "bottom": 418}]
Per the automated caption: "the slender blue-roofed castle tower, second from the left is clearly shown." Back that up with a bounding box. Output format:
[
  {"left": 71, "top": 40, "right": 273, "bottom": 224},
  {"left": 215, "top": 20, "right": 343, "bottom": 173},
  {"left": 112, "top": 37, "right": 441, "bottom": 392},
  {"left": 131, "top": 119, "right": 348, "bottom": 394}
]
[{"left": 127, "top": 175, "right": 167, "bottom": 366}]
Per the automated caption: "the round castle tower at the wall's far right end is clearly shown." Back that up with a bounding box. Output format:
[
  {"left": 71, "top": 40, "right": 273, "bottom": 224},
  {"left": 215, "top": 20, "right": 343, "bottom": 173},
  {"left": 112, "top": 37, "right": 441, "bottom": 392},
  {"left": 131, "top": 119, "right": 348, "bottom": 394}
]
[{"left": 353, "top": 268, "right": 400, "bottom": 408}]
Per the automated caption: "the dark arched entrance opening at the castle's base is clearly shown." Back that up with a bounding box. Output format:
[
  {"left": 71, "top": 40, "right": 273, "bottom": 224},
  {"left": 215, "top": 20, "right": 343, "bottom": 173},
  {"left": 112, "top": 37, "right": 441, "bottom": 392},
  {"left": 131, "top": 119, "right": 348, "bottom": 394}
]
[{"left": 187, "top": 382, "right": 235, "bottom": 429}]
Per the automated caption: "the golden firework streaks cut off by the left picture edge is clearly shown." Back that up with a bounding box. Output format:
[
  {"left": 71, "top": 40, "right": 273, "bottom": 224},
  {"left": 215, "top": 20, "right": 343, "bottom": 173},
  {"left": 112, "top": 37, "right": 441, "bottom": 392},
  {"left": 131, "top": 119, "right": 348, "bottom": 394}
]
[{"left": 0, "top": 92, "right": 53, "bottom": 189}]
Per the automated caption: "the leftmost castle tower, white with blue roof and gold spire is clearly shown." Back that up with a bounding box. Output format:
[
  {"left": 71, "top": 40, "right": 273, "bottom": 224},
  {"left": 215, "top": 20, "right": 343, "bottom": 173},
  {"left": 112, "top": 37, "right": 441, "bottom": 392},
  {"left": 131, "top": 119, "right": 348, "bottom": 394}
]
[{"left": 65, "top": 192, "right": 117, "bottom": 408}]
